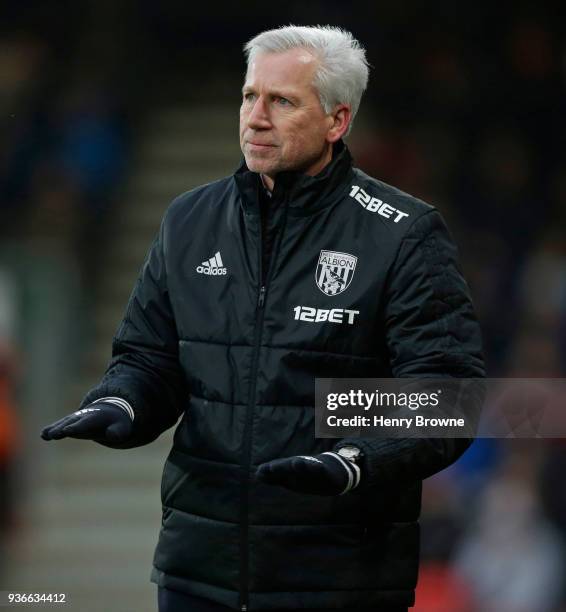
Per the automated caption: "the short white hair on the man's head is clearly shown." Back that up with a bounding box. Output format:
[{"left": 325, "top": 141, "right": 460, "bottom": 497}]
[{"left": 244, "top": 25, "right": 369, "bottom": 136}]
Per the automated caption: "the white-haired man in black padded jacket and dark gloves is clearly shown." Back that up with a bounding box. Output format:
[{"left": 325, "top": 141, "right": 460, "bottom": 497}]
[{"left": 43, "top": 26, "right": 484, "bottom": 612}]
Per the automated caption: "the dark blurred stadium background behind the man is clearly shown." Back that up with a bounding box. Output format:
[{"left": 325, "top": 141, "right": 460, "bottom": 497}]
[{"left": 0, "top": 0, "right": 566, "bottom": 612}]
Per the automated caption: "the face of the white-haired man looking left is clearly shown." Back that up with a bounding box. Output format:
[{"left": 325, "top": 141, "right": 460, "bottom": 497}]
[{"left": 240, "top": 49, "right": 336, "bottom": 186}]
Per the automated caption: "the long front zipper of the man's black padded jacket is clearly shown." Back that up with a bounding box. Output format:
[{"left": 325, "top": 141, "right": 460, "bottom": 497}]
[{"left": 240, "top": 194, "right": 287, "bottom": 612}]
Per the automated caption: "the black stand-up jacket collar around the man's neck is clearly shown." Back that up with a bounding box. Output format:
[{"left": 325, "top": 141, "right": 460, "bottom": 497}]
[{"left": 234, "top": 140, "right": 352, "bottom": 216}]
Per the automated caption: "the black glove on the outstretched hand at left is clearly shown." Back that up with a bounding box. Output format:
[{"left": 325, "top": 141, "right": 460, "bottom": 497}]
[{"left": 41, "top": 402, "right": 132, "bottom": 444}]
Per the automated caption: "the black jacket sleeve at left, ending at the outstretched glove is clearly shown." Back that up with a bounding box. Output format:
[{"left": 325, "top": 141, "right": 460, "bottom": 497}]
[{"left": 81, "top": 214, "right": 186, "bottom": 448}]
